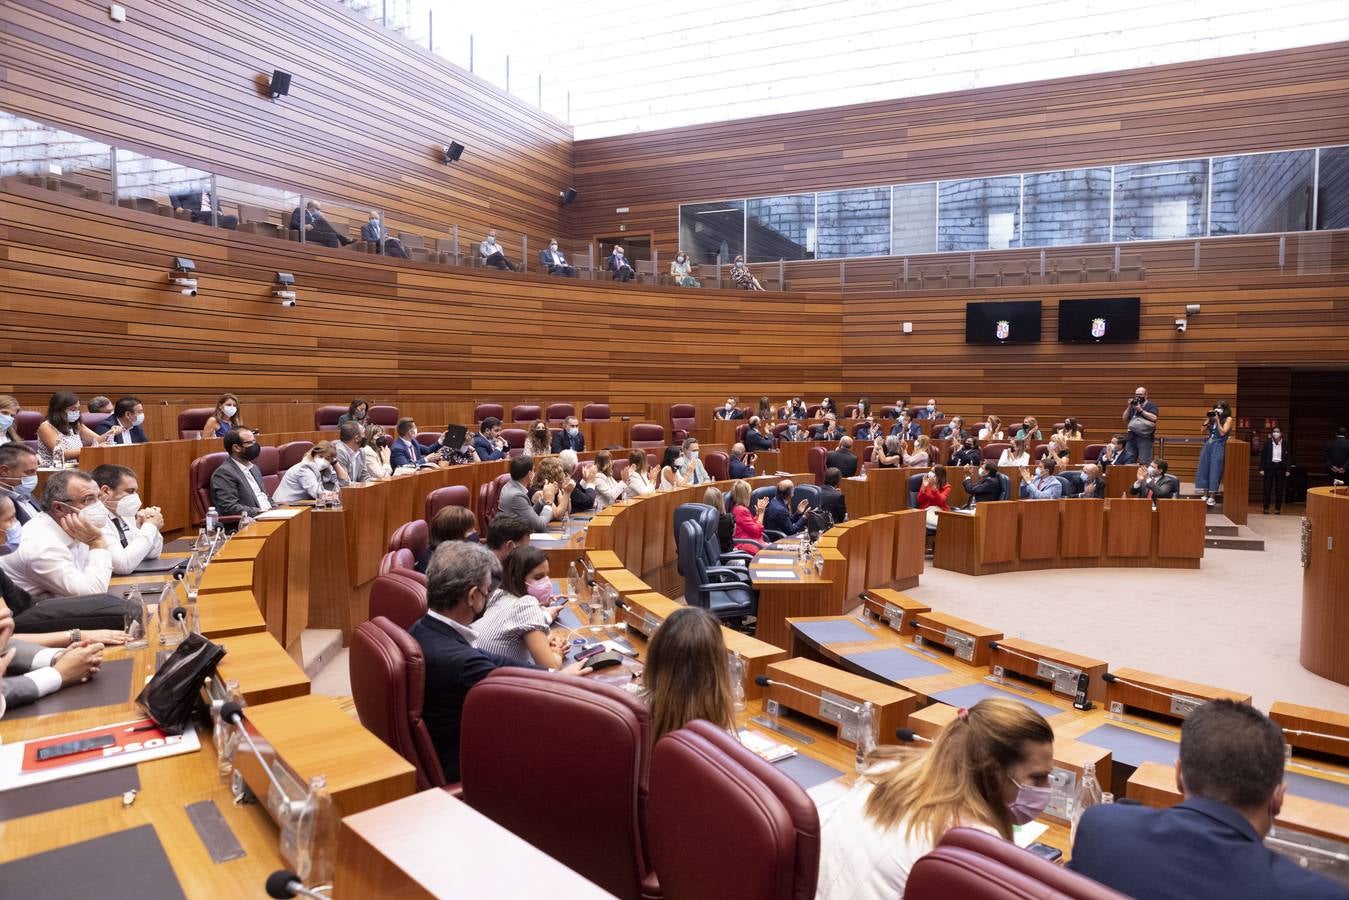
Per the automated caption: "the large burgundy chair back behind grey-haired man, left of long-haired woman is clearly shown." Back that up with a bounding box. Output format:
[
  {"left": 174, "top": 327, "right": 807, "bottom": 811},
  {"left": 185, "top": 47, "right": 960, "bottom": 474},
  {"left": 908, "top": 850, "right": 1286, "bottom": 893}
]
[{"left": 459, "top": 668, "right": 655, "bottom": 900}]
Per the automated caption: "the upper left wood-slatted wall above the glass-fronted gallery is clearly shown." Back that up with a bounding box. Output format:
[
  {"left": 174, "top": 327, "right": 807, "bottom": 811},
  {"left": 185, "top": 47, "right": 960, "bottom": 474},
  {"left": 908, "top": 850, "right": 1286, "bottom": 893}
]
[{"left": 0, "top": 0, "right": 572, "bottom": 246}]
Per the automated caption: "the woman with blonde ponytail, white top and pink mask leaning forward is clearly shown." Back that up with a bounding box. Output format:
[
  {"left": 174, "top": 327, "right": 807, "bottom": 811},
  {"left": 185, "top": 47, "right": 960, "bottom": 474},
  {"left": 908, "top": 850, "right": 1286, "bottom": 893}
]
[{"left": 815, "top": 698, "right": 1054, "bottom": 900}]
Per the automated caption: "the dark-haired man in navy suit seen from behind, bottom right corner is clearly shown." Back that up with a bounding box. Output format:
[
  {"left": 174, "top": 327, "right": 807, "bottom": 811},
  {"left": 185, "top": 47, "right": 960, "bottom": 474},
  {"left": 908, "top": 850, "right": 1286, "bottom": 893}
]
[{"left": 1068, "top": 699, "right": 1345, "bottom": 900}]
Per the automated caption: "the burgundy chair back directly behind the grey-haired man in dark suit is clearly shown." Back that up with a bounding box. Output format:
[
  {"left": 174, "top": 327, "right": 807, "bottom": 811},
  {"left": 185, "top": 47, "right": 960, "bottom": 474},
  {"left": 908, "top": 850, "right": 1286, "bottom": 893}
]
[{"left": 349, "top": 617, "right": 445, "bottom": 791}]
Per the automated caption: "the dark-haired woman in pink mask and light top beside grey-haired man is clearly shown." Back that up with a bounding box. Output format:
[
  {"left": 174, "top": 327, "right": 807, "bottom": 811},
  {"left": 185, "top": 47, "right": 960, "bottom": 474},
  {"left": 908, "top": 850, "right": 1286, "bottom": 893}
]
[{"left": 473, "top": 546, "right": 568, "bottom": 669}]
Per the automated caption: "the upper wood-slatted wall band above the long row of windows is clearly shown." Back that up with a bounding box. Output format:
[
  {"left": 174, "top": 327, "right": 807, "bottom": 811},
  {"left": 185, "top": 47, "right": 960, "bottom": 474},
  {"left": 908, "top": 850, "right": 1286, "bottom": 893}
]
[{"left": 568, "top": 43, "right": 1349, "bottom": 261}]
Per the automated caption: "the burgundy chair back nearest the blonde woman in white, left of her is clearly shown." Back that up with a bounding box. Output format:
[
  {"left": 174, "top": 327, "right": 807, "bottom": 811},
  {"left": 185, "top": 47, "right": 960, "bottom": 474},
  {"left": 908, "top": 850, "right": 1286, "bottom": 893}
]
[{"left": 646, "top": 721, "right": 814, "bottom": 900}]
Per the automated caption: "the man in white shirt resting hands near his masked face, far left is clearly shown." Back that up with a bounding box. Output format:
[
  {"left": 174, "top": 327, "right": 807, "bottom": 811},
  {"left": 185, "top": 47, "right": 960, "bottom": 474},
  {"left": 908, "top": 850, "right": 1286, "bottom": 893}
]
[{"left": 0, "top": 470, "right": 112, "bottom": 600}]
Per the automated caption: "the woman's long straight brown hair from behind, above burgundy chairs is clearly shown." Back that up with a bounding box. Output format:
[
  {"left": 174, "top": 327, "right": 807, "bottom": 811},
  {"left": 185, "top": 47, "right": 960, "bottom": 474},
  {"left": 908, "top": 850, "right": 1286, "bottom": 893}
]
[{"left": 642, "top": 606, "right": 735, "bottom": 743}]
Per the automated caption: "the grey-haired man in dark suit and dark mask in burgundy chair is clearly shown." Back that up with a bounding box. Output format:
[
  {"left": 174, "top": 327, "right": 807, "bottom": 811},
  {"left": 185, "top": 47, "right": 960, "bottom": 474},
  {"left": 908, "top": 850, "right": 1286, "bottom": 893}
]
[{"left": 409, "top": 541, "right": 588, "bottom": 781}]
